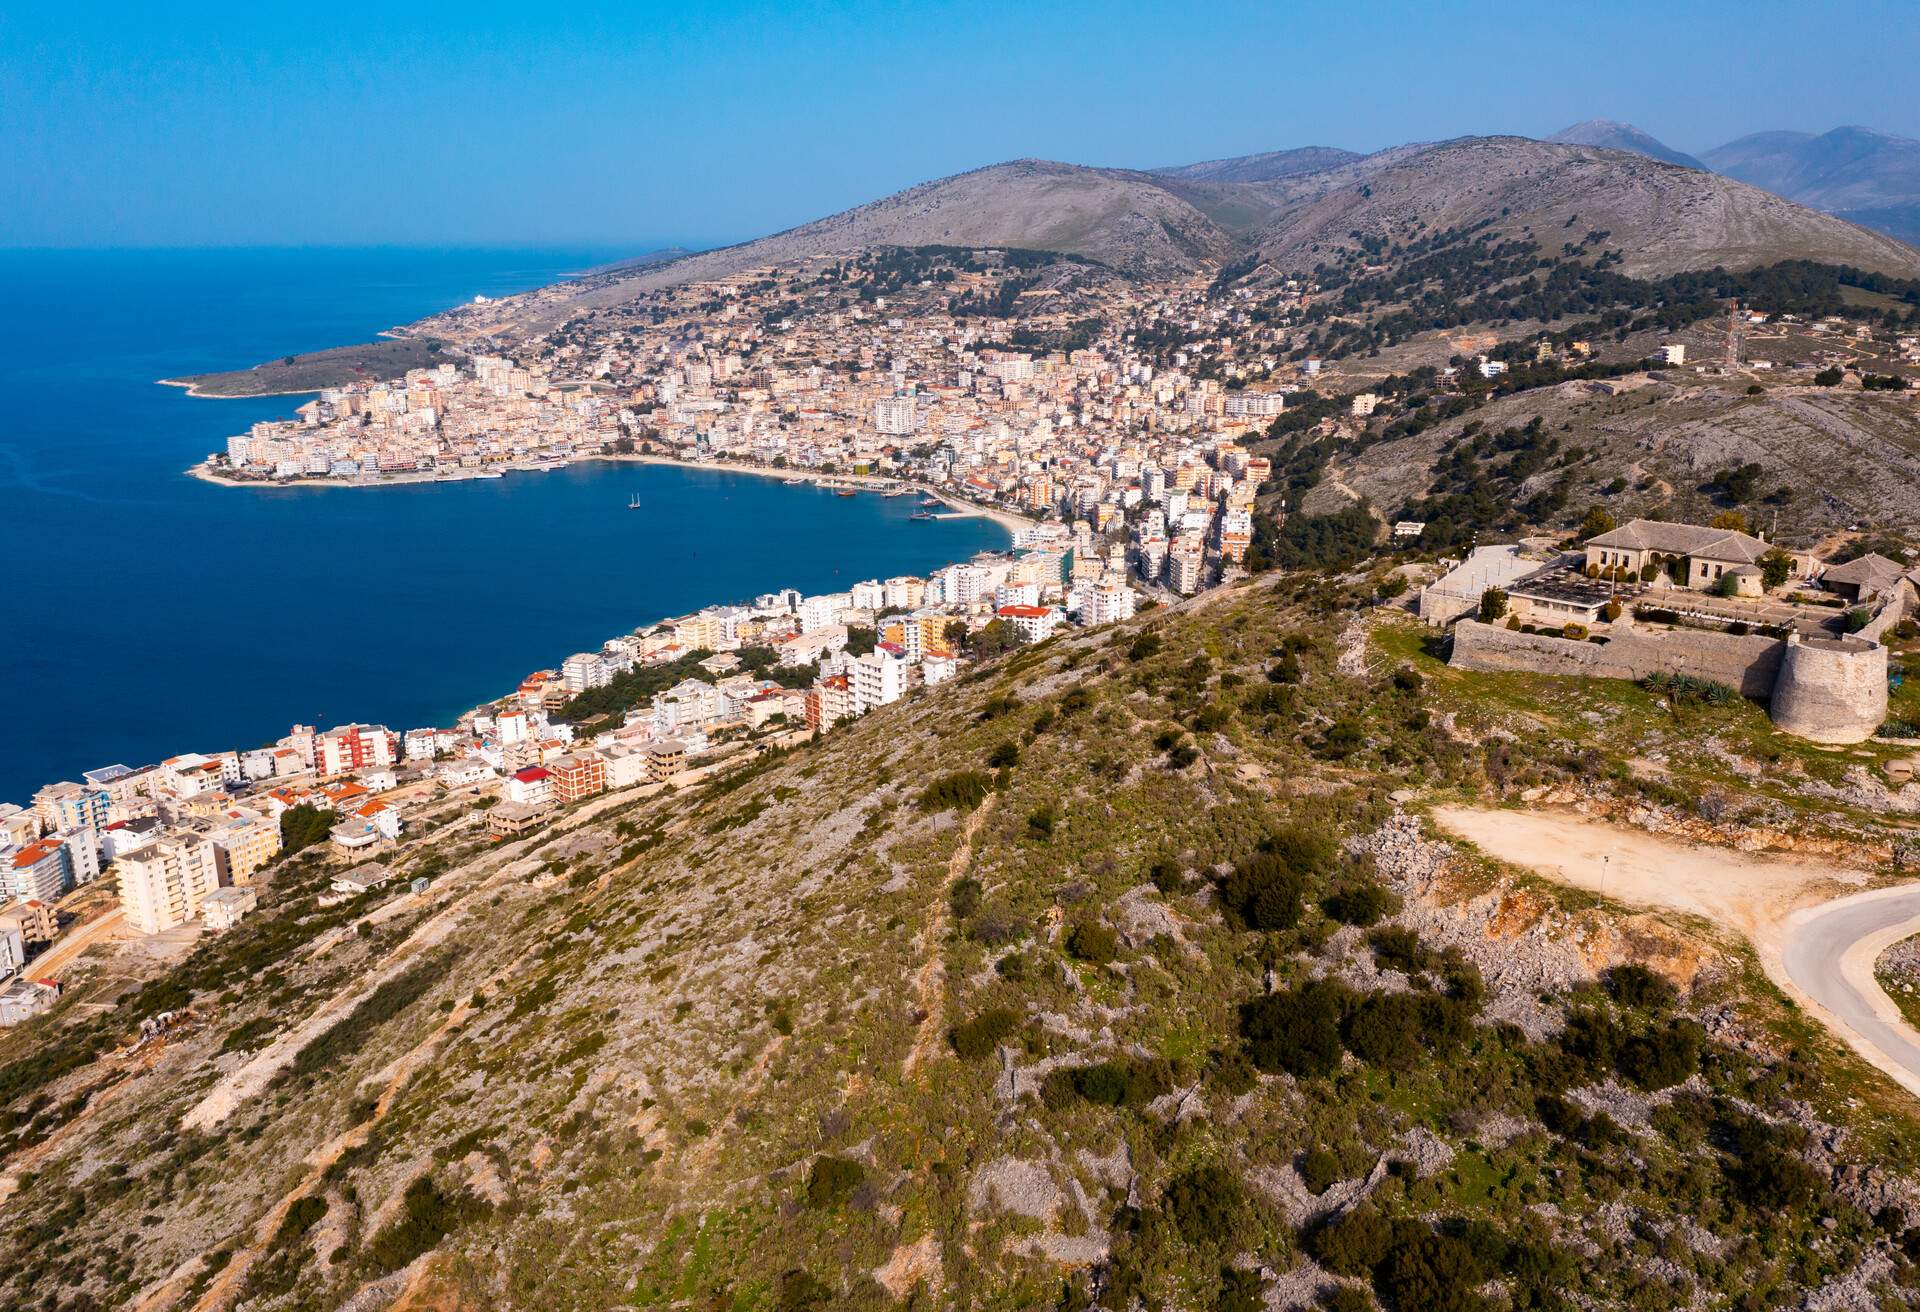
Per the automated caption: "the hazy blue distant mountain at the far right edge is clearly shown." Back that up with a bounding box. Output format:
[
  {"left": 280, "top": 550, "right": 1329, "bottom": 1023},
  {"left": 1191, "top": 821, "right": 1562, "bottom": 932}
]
[{"left": 1703, "top": 127, "right": 1920, "bottom": 242}]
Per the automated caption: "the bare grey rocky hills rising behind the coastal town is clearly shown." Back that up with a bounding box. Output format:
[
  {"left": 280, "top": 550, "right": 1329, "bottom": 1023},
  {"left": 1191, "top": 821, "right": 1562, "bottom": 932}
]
[{"left": 405, "top": 136, "right": 1920, "bottom": 343}]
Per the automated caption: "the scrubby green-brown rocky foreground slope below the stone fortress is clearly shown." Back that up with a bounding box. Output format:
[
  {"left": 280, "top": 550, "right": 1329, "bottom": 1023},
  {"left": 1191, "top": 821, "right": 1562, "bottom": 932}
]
[{"left": 0, "top": 572, "right": 1920, "bottom": 1312}]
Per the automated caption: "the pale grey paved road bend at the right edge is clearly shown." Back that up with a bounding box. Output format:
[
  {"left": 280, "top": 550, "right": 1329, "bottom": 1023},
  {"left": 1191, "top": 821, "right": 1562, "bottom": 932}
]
[{"left": 1782, "top": 886, "right": 1920, "bottom": 1093}]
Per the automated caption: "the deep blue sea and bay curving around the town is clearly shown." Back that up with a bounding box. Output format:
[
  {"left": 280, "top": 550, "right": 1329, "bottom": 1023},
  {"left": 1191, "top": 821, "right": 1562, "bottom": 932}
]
[{"left": 0, "top": 248, "right": 1006, "bottom": 803}]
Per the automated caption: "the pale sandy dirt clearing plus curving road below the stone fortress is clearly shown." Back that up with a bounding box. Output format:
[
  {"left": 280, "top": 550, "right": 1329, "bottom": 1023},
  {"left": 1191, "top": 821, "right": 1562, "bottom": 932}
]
[{"left": 1434, "top": 807, "right": 1920, "bottom": 1097}]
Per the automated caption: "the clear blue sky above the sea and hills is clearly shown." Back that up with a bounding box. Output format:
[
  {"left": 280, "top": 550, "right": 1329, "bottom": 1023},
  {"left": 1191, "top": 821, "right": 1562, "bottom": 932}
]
[{"left": 0, "top": 0, "right": 1920, "bottom": 246}]
